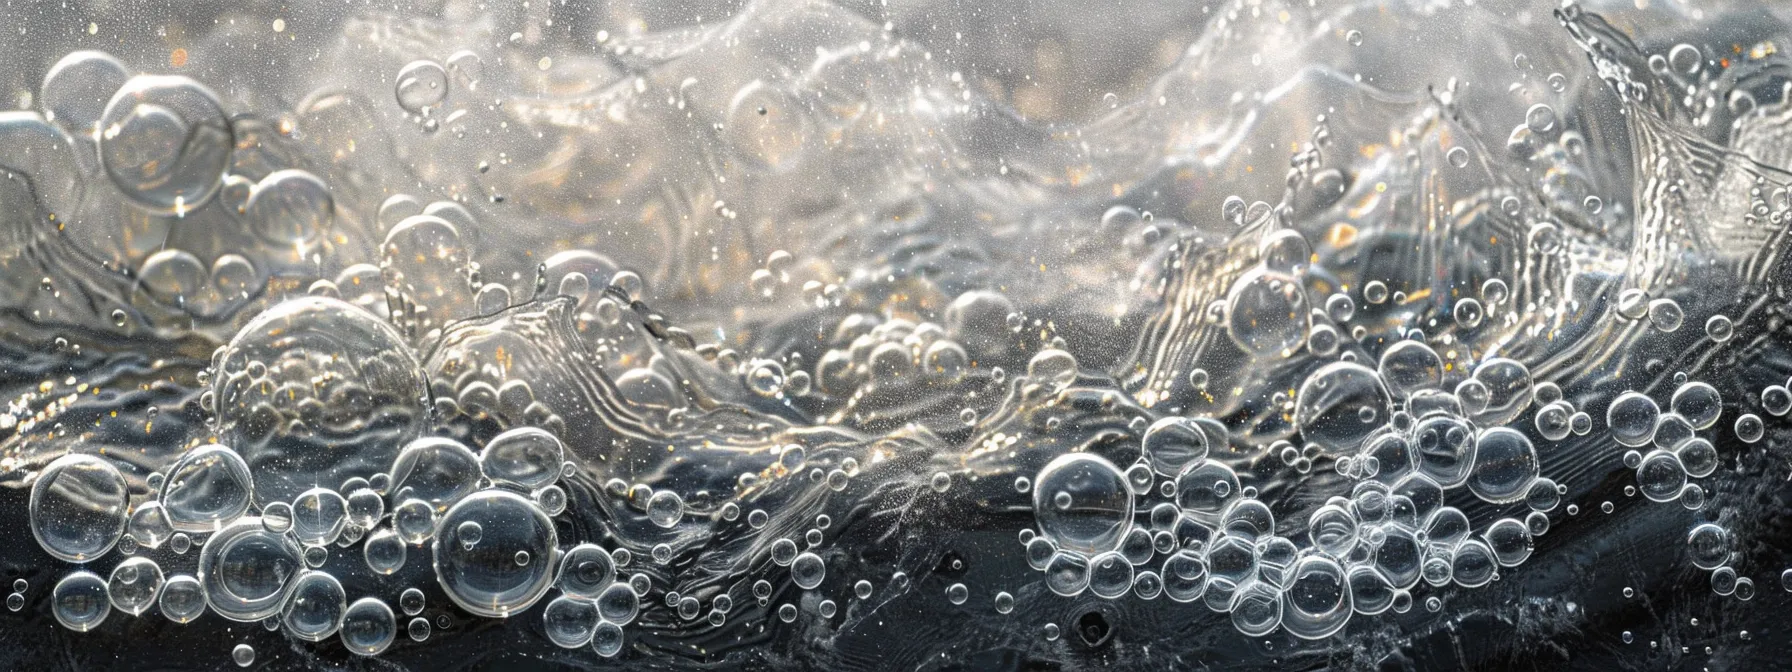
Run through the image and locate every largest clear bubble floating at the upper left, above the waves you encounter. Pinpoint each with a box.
[99,75,237,215]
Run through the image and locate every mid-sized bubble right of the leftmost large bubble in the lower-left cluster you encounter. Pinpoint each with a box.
[161,443,254,532]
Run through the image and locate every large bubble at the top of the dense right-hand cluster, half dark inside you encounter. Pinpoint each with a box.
[1294,362,1391,455]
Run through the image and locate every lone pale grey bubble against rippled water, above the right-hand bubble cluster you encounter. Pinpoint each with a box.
[1226,267,1308,357]
